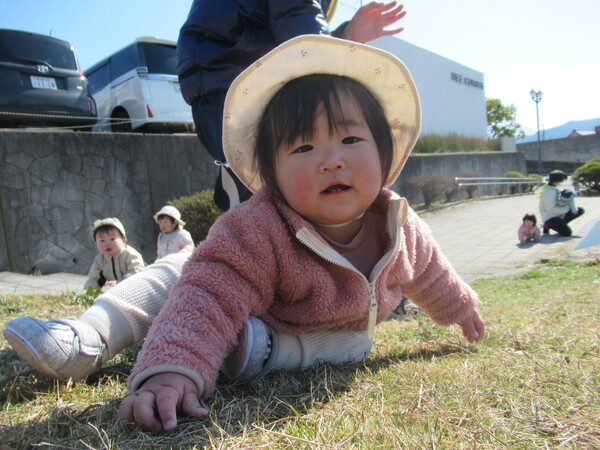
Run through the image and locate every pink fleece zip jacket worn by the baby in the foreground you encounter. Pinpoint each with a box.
[129,189,478,397]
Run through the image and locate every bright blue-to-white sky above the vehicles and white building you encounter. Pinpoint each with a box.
[0,0,600,132]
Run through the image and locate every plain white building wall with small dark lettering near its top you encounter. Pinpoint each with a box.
[369,36,487,139]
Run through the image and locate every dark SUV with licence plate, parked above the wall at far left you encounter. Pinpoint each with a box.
[0,29,96,129]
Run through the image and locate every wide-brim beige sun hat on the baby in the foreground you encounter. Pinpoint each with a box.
[223,35,421,192]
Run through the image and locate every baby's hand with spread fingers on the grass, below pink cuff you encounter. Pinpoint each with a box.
[119,372,208,431]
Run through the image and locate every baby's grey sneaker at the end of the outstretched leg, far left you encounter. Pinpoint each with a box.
[4,317,108,381]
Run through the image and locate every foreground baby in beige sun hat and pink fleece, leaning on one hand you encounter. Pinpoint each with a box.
[119,36,484,430]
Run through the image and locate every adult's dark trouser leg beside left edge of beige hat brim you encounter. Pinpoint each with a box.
[192,91,252,211]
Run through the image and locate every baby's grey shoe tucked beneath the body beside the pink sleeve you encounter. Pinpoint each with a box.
[221,316,279,381]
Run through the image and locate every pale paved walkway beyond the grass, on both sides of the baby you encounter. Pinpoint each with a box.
[0,195,600,295]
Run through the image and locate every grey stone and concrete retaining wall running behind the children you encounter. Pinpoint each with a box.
[0,130,525,274]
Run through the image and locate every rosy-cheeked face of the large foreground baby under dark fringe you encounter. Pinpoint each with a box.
[275,95,383,239]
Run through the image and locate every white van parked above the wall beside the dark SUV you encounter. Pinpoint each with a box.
[85,37,194,132]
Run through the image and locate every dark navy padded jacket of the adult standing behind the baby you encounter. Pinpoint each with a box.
[177,0,337,104]
